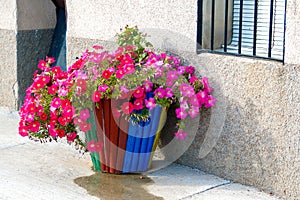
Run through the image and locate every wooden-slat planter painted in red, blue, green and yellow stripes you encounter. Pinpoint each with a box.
[87,99,167,174]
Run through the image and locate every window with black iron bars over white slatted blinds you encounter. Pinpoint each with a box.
[197,0,286,61]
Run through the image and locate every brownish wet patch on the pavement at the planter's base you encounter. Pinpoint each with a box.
[74,172,163,200]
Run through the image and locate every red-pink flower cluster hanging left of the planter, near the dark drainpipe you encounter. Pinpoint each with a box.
[19,57,83,149]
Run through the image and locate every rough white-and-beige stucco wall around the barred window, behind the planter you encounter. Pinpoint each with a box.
[67,0,300,199]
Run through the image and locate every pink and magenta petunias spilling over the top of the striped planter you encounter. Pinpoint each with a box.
[71,28,215,139]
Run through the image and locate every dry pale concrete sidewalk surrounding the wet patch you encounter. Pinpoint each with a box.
[0,108,277,200]
